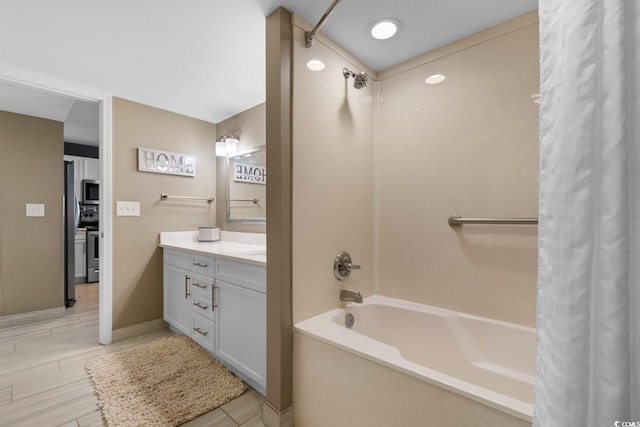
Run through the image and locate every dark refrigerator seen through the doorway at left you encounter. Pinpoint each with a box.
[63,161,80,307]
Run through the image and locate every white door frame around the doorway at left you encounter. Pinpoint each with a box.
[0,70,113,345]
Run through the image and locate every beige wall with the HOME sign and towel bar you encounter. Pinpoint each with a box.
[113,98,217,329]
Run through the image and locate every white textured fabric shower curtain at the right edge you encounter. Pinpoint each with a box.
[534,0,640,427]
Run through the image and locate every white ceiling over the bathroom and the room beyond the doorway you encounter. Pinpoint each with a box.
[0,0,537,144]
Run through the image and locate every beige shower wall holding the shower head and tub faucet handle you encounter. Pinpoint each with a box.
[292,16,375,323]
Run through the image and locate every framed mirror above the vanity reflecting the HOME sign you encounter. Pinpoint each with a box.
[227,145,267,224]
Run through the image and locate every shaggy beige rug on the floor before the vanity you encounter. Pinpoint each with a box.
[86,335,246,427]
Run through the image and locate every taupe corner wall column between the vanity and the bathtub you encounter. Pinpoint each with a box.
[263,8,293,427]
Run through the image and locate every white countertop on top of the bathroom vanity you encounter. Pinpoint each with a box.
[160,231,267,266]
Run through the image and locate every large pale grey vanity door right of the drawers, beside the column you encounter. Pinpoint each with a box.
[215,280,267,394]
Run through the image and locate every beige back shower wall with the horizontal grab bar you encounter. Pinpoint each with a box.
[376,12,539,326]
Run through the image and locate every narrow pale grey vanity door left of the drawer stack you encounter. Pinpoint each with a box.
[163,264,191,336]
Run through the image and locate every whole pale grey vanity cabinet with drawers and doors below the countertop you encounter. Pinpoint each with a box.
[163,248,267,394]
